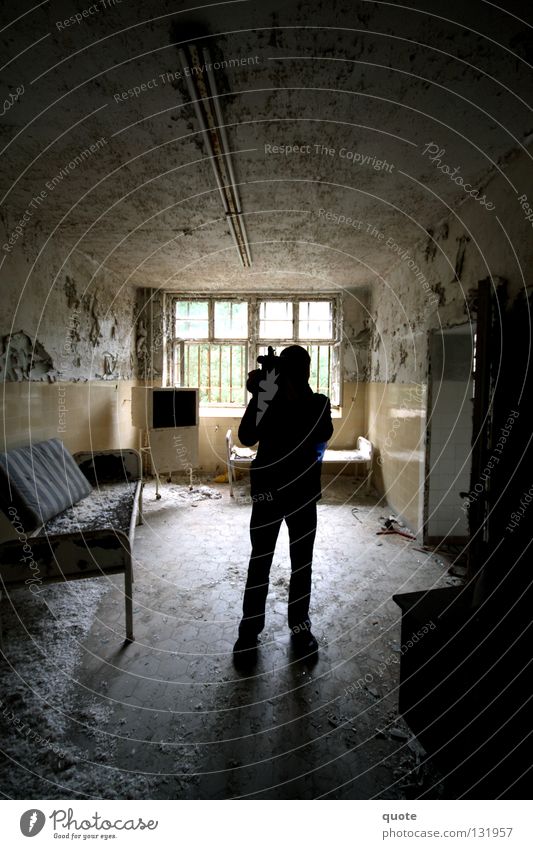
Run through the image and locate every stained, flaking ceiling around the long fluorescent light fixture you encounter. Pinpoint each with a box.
[1,0,533,292]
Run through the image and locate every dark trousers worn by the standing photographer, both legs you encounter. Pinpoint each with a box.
[239,501,316,636]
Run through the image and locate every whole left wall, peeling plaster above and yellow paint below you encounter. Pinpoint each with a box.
[0,222,138,450]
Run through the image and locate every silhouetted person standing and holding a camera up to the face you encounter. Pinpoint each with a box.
[233,345,333,665]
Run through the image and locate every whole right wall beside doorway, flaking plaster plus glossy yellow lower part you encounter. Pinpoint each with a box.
[367,146,533,529]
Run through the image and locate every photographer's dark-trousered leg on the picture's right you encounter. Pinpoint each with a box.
[285,502,316,634]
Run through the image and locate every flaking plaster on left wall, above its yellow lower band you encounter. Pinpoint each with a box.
[0,234,136,383]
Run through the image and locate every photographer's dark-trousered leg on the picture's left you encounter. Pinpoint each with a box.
[239,502,283,638]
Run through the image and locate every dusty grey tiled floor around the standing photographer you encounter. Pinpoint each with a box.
[1,478,453,799]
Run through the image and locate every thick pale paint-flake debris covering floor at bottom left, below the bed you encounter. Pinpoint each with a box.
[0,579,154,799]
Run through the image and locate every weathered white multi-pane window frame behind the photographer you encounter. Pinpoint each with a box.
[165,292,342,411]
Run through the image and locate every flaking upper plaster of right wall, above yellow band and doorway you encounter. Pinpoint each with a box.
[370,146,533,383]
